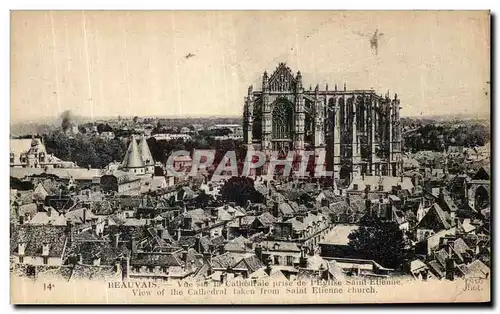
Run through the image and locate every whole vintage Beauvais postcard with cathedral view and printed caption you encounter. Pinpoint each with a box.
[10,11,492,304]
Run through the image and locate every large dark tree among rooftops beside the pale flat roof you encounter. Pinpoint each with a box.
[349,216,405,268]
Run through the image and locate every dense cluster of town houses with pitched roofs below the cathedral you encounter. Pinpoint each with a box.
[10,137,491,282]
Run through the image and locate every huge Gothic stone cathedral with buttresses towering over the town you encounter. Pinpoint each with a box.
[243,63,402,178]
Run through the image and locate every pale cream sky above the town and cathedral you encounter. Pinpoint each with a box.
[11,11,490,122]
